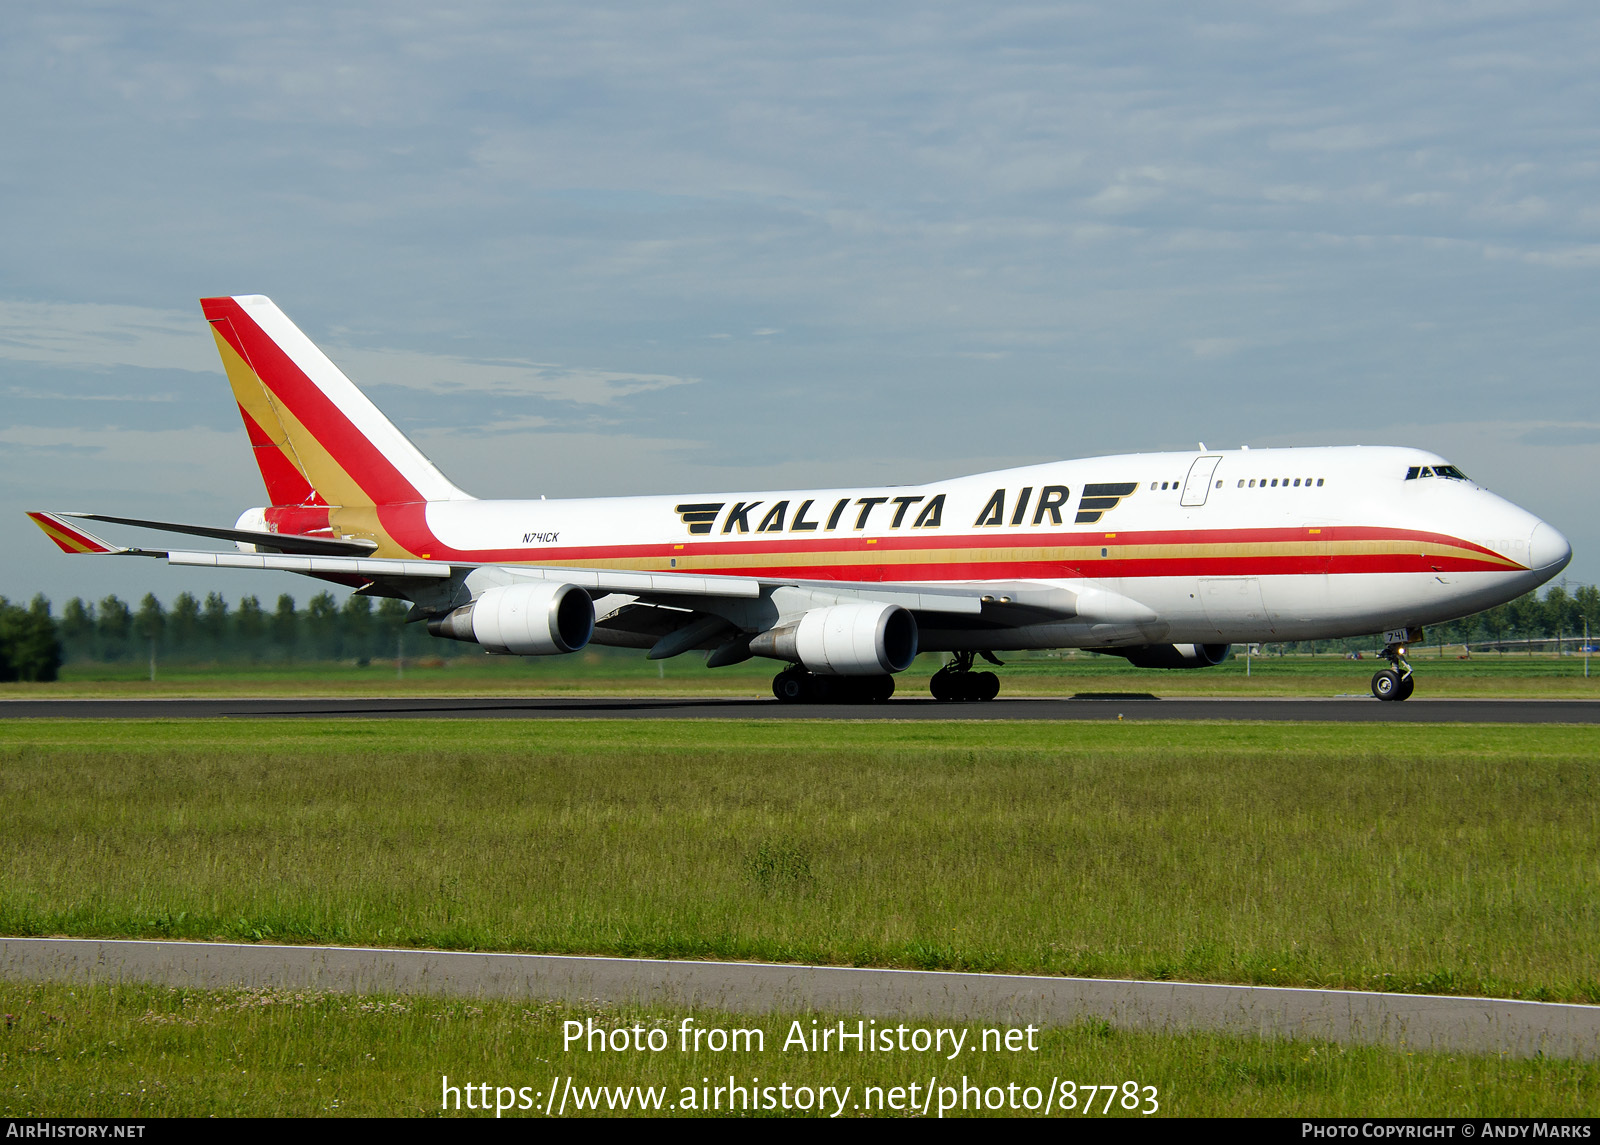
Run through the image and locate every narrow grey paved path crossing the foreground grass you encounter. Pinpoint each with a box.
[0,939,1600,1059]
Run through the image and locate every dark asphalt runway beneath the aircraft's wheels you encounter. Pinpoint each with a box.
[0,692,1600,724]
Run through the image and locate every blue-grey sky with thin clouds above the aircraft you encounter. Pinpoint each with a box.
[0,0,1600,608]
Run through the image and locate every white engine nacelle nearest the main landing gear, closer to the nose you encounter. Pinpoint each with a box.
[750,601,917,676]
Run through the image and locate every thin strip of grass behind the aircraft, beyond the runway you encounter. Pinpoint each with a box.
[12,646,1600,699]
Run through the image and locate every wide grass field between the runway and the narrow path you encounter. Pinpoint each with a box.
[0,721,1600,1003]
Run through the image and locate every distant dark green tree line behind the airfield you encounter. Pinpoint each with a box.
[9,585,1600,681]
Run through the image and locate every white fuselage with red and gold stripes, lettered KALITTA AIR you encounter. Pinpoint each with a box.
[347,446,1571,651]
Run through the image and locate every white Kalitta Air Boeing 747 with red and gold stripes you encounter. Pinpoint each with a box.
[30,294,1571,702]
